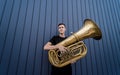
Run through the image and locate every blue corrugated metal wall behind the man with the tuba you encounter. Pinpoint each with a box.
[0,0,120,75]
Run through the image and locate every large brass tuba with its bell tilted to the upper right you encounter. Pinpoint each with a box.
[48,19,102,67]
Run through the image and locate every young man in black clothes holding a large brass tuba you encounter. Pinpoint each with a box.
[44,23,72,75]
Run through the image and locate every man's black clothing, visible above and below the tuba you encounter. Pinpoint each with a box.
[49,35,72,75]
